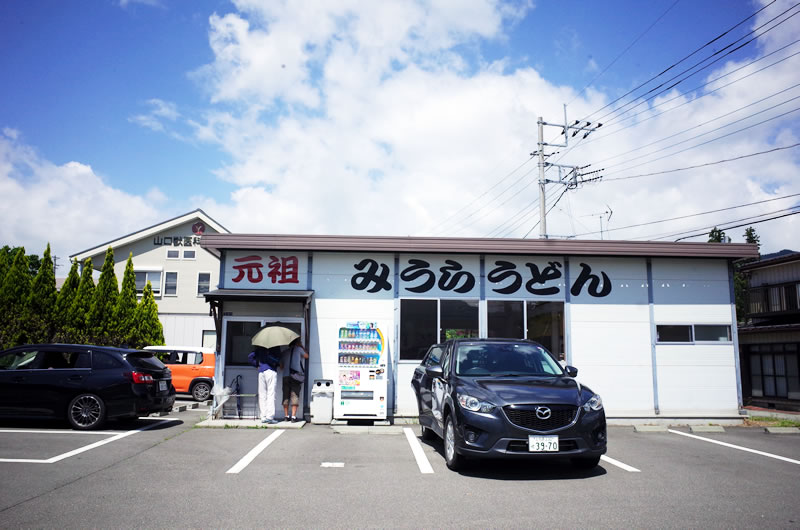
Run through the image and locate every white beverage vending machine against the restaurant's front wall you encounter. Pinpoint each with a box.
[333,321,388,420]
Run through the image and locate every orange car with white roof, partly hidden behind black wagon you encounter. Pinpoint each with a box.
[145,346,217,401]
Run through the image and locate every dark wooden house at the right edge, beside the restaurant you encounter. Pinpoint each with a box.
[739,252,800,410]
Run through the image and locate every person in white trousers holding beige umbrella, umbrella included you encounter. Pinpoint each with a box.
[248,326,299,425]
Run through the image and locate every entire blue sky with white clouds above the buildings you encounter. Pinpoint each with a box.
[0,0,800,264]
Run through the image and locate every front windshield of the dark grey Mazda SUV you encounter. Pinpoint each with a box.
[456,342,564,377]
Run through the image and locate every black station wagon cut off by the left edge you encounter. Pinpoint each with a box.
[0,344,175,430]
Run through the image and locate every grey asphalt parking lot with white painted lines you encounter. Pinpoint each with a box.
[0,402,800,528]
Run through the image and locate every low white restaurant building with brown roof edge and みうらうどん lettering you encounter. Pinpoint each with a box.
[201,233,758,419]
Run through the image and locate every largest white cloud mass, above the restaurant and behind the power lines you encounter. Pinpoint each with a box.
[170,0,800,250]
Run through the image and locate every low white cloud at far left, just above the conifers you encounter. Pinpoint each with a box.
[0,130,164,266]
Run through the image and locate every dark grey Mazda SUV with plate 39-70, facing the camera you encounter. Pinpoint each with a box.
[411,339,606,470]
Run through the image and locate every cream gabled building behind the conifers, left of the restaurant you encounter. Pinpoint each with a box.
[70,209,228,347]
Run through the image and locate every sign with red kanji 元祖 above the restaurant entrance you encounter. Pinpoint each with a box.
[223,250,308,290]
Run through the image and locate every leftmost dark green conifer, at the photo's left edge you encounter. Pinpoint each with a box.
[0,247,31,348]
